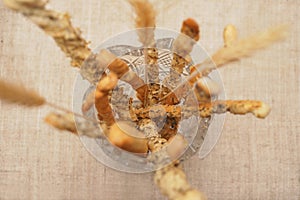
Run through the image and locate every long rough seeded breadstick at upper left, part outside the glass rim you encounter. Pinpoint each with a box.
[4,0,91,67]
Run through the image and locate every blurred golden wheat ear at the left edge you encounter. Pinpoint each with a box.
[0,80,46,106]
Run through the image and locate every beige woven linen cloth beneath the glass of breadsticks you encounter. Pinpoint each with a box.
[0,0,300,200]
